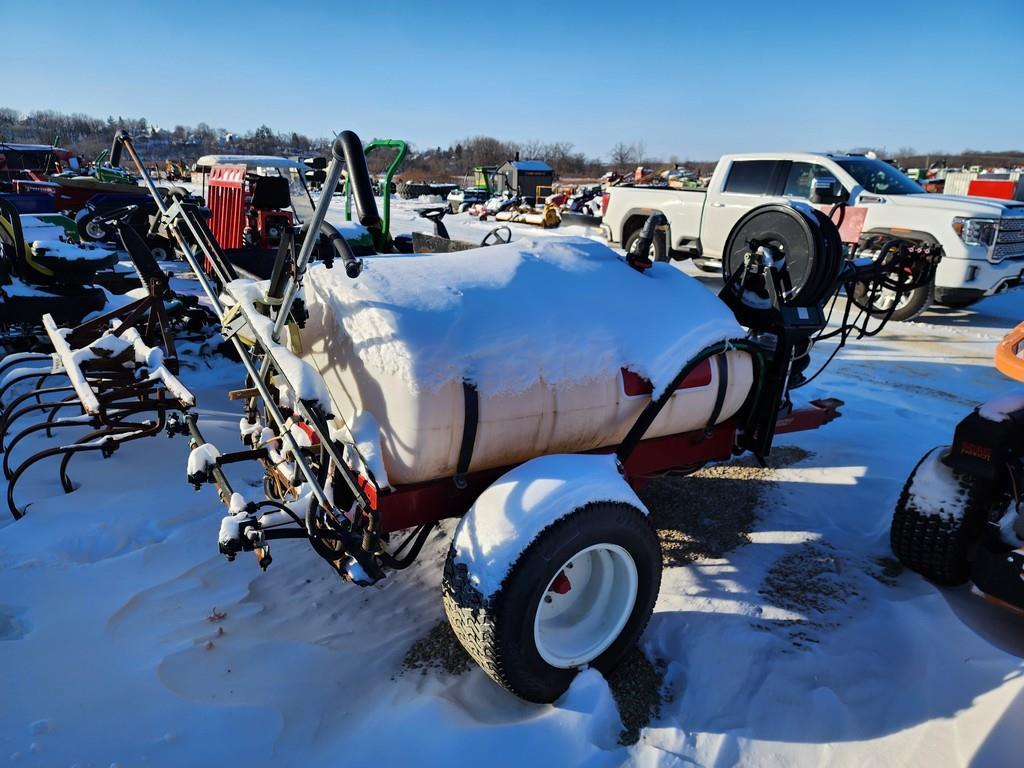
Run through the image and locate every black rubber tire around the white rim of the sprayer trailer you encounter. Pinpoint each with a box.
[441,502,662,703]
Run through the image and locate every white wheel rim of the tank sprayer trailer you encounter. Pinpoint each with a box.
[534,544,639,669]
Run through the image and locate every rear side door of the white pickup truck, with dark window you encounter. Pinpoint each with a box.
[700,160,782,259]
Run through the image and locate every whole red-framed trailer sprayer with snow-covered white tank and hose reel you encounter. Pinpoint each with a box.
[120,131,929,701]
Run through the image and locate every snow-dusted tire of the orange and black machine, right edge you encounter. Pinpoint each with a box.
[889,445,985,586]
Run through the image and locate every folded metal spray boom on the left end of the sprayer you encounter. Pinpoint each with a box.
[109,131,390,581]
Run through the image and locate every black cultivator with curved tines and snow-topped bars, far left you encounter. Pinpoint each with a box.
[0,280,196,519]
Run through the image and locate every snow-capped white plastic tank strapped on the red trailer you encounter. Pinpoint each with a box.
[302,238,752,483]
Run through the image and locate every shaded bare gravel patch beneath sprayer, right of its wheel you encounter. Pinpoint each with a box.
[640,445,811,567]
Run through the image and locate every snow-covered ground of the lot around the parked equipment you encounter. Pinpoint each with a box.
[0,202,1024,768]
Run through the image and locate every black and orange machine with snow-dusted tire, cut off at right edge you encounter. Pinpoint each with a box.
[890,323,1024,614]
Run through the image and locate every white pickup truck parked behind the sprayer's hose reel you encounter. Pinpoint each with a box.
[601,153,1024,319]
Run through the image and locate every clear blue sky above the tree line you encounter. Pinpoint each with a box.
[0,0,1024,159]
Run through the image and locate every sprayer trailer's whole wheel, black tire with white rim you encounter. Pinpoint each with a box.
[441,502,662,702]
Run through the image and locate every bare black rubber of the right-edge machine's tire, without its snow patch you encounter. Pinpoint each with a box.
[889,446,987,586]
